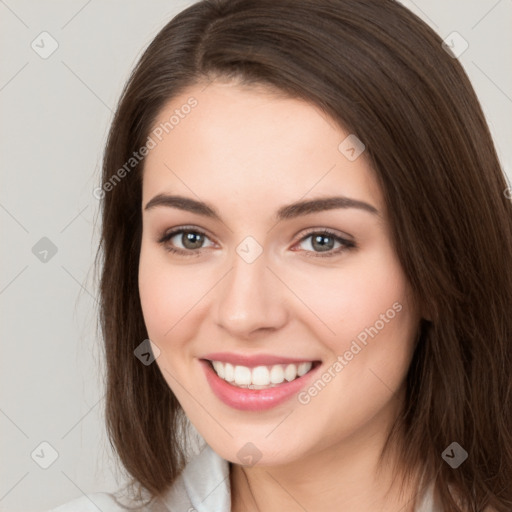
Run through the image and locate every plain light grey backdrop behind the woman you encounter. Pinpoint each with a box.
[0,0,512,512]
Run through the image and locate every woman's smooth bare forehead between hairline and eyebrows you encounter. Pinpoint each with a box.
[143,82,383,218]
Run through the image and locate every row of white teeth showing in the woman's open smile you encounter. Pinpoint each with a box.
[204,359,321,389]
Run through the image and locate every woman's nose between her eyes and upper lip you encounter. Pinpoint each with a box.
[215,251,289,339]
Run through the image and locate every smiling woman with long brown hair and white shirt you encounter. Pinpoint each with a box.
[50,0,512,512]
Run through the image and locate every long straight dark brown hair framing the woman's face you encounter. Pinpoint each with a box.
[96,0,512,512]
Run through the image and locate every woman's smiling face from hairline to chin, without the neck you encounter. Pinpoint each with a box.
[139,81,420,465]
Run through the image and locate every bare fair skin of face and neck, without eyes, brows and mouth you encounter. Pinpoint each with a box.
[139,80,421,512]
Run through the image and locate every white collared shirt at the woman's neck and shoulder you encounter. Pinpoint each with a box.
[48,444,440,512]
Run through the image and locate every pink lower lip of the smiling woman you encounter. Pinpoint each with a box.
[199,359,320,411]
